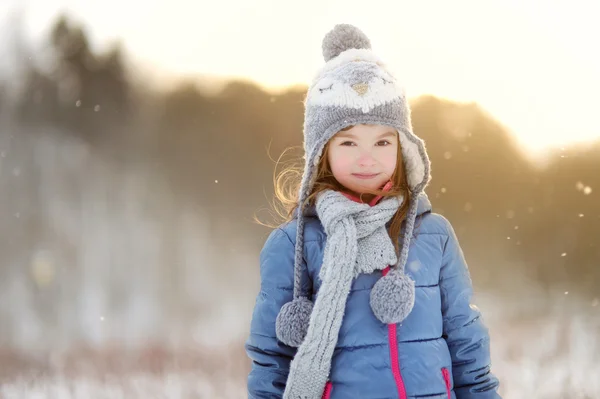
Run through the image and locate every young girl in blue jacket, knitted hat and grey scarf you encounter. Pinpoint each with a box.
[246,25,500,399]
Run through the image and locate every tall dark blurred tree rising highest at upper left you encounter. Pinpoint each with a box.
[19,15,131,139]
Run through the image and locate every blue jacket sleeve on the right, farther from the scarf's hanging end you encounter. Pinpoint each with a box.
[440,220,500,399]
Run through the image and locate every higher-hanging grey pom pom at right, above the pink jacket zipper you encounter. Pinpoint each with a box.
[370,269,415,324]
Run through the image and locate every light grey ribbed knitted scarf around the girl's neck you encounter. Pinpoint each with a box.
[283,191,402,399]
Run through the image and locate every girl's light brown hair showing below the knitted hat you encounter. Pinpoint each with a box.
[255,126,412,252]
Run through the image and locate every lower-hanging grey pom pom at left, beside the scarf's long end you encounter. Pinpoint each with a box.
[275,297,313,348]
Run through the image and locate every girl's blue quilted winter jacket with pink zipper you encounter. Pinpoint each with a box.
[246,194,500,399]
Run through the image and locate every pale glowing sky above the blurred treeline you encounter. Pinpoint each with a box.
[0,0,600,157]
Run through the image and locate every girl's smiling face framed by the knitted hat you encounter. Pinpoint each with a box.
[327,125,398,194]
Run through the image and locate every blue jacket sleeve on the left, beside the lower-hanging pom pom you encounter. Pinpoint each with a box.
[245,229,297,399]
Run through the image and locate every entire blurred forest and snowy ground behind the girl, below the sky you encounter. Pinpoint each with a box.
[0,7,600,399]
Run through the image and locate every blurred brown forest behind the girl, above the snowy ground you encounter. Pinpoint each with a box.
[0,10,600,398]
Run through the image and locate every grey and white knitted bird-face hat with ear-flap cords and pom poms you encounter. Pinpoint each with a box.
[276,24,430,347]
